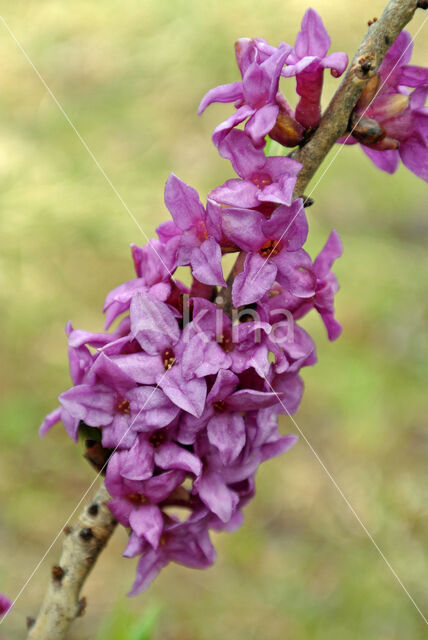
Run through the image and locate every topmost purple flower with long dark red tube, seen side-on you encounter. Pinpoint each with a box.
[282,9,348,129]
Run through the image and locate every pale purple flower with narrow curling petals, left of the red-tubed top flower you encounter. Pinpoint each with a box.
[199,40,291,147]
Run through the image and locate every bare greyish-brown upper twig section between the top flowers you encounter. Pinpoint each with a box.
[293,0,418,197]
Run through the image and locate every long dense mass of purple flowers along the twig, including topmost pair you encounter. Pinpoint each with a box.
[40,6,346,594]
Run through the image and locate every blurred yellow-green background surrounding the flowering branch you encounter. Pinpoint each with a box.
[0,0,428,640]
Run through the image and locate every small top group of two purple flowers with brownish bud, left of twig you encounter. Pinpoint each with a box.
[199,9,348,149]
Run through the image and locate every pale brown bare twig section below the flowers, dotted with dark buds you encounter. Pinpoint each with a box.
[27,484,117,640]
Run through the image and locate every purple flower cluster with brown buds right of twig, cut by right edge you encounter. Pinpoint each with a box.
[346,31,428,181]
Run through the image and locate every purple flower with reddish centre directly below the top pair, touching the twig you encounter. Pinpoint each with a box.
[208,129,302,209]
